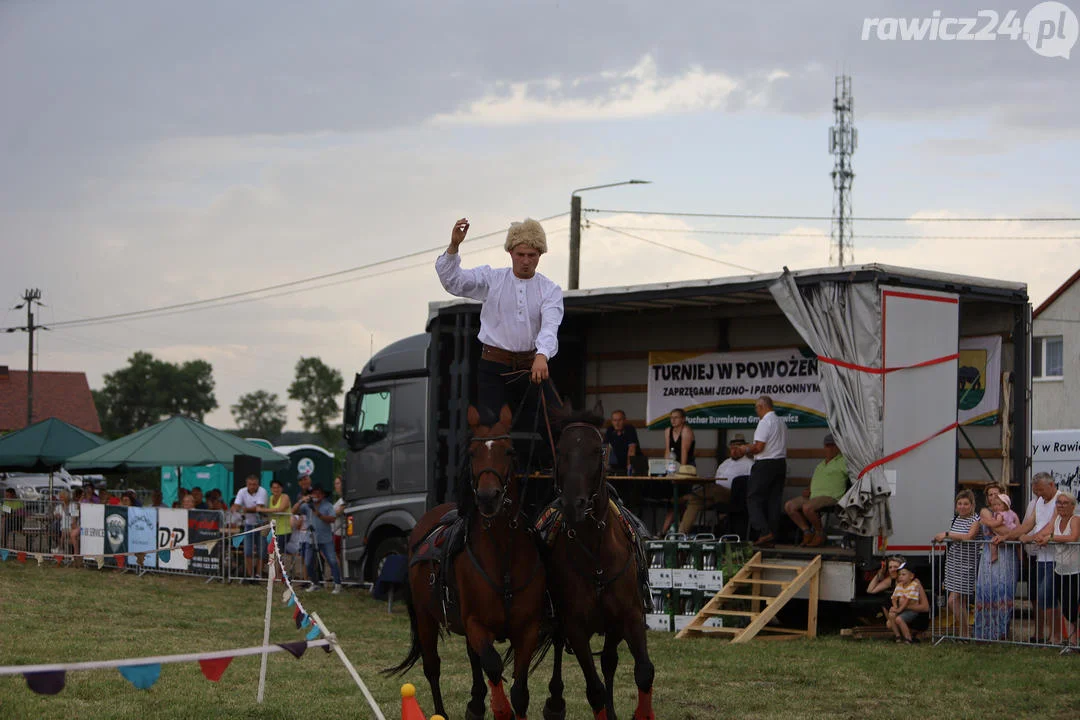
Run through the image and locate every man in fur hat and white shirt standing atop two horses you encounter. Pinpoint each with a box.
[435,218,563,431]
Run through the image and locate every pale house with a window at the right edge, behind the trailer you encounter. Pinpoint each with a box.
[1031,270,1080,430]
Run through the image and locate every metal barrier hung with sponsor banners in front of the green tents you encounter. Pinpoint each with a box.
[0,498,231,582]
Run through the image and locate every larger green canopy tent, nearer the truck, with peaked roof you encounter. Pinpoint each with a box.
[64,416,288,505]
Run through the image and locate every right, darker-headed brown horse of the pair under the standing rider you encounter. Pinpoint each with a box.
[543,422,656,720]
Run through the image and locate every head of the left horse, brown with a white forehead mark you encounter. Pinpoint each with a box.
[469,405,515,518]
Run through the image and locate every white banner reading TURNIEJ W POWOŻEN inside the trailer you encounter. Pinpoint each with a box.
[647,348,827,430]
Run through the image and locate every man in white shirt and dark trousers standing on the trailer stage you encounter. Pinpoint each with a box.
[744,395,787,547]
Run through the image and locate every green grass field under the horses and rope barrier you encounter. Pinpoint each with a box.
[0,559,1080,720]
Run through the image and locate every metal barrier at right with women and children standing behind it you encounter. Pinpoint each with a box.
[927,540,1080,650]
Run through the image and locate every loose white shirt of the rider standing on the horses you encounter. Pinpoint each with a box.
[435,253,563,359]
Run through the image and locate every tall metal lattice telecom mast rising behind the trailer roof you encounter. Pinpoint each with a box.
[828,74,859,268]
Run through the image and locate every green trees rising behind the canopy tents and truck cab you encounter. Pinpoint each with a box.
[93,351,345,447]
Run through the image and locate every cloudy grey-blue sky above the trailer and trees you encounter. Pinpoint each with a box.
[0,0,1080,429]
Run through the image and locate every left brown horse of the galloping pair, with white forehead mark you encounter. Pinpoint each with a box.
[387,406,545,720]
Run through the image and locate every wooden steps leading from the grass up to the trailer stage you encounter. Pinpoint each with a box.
[675,553,821,642]
